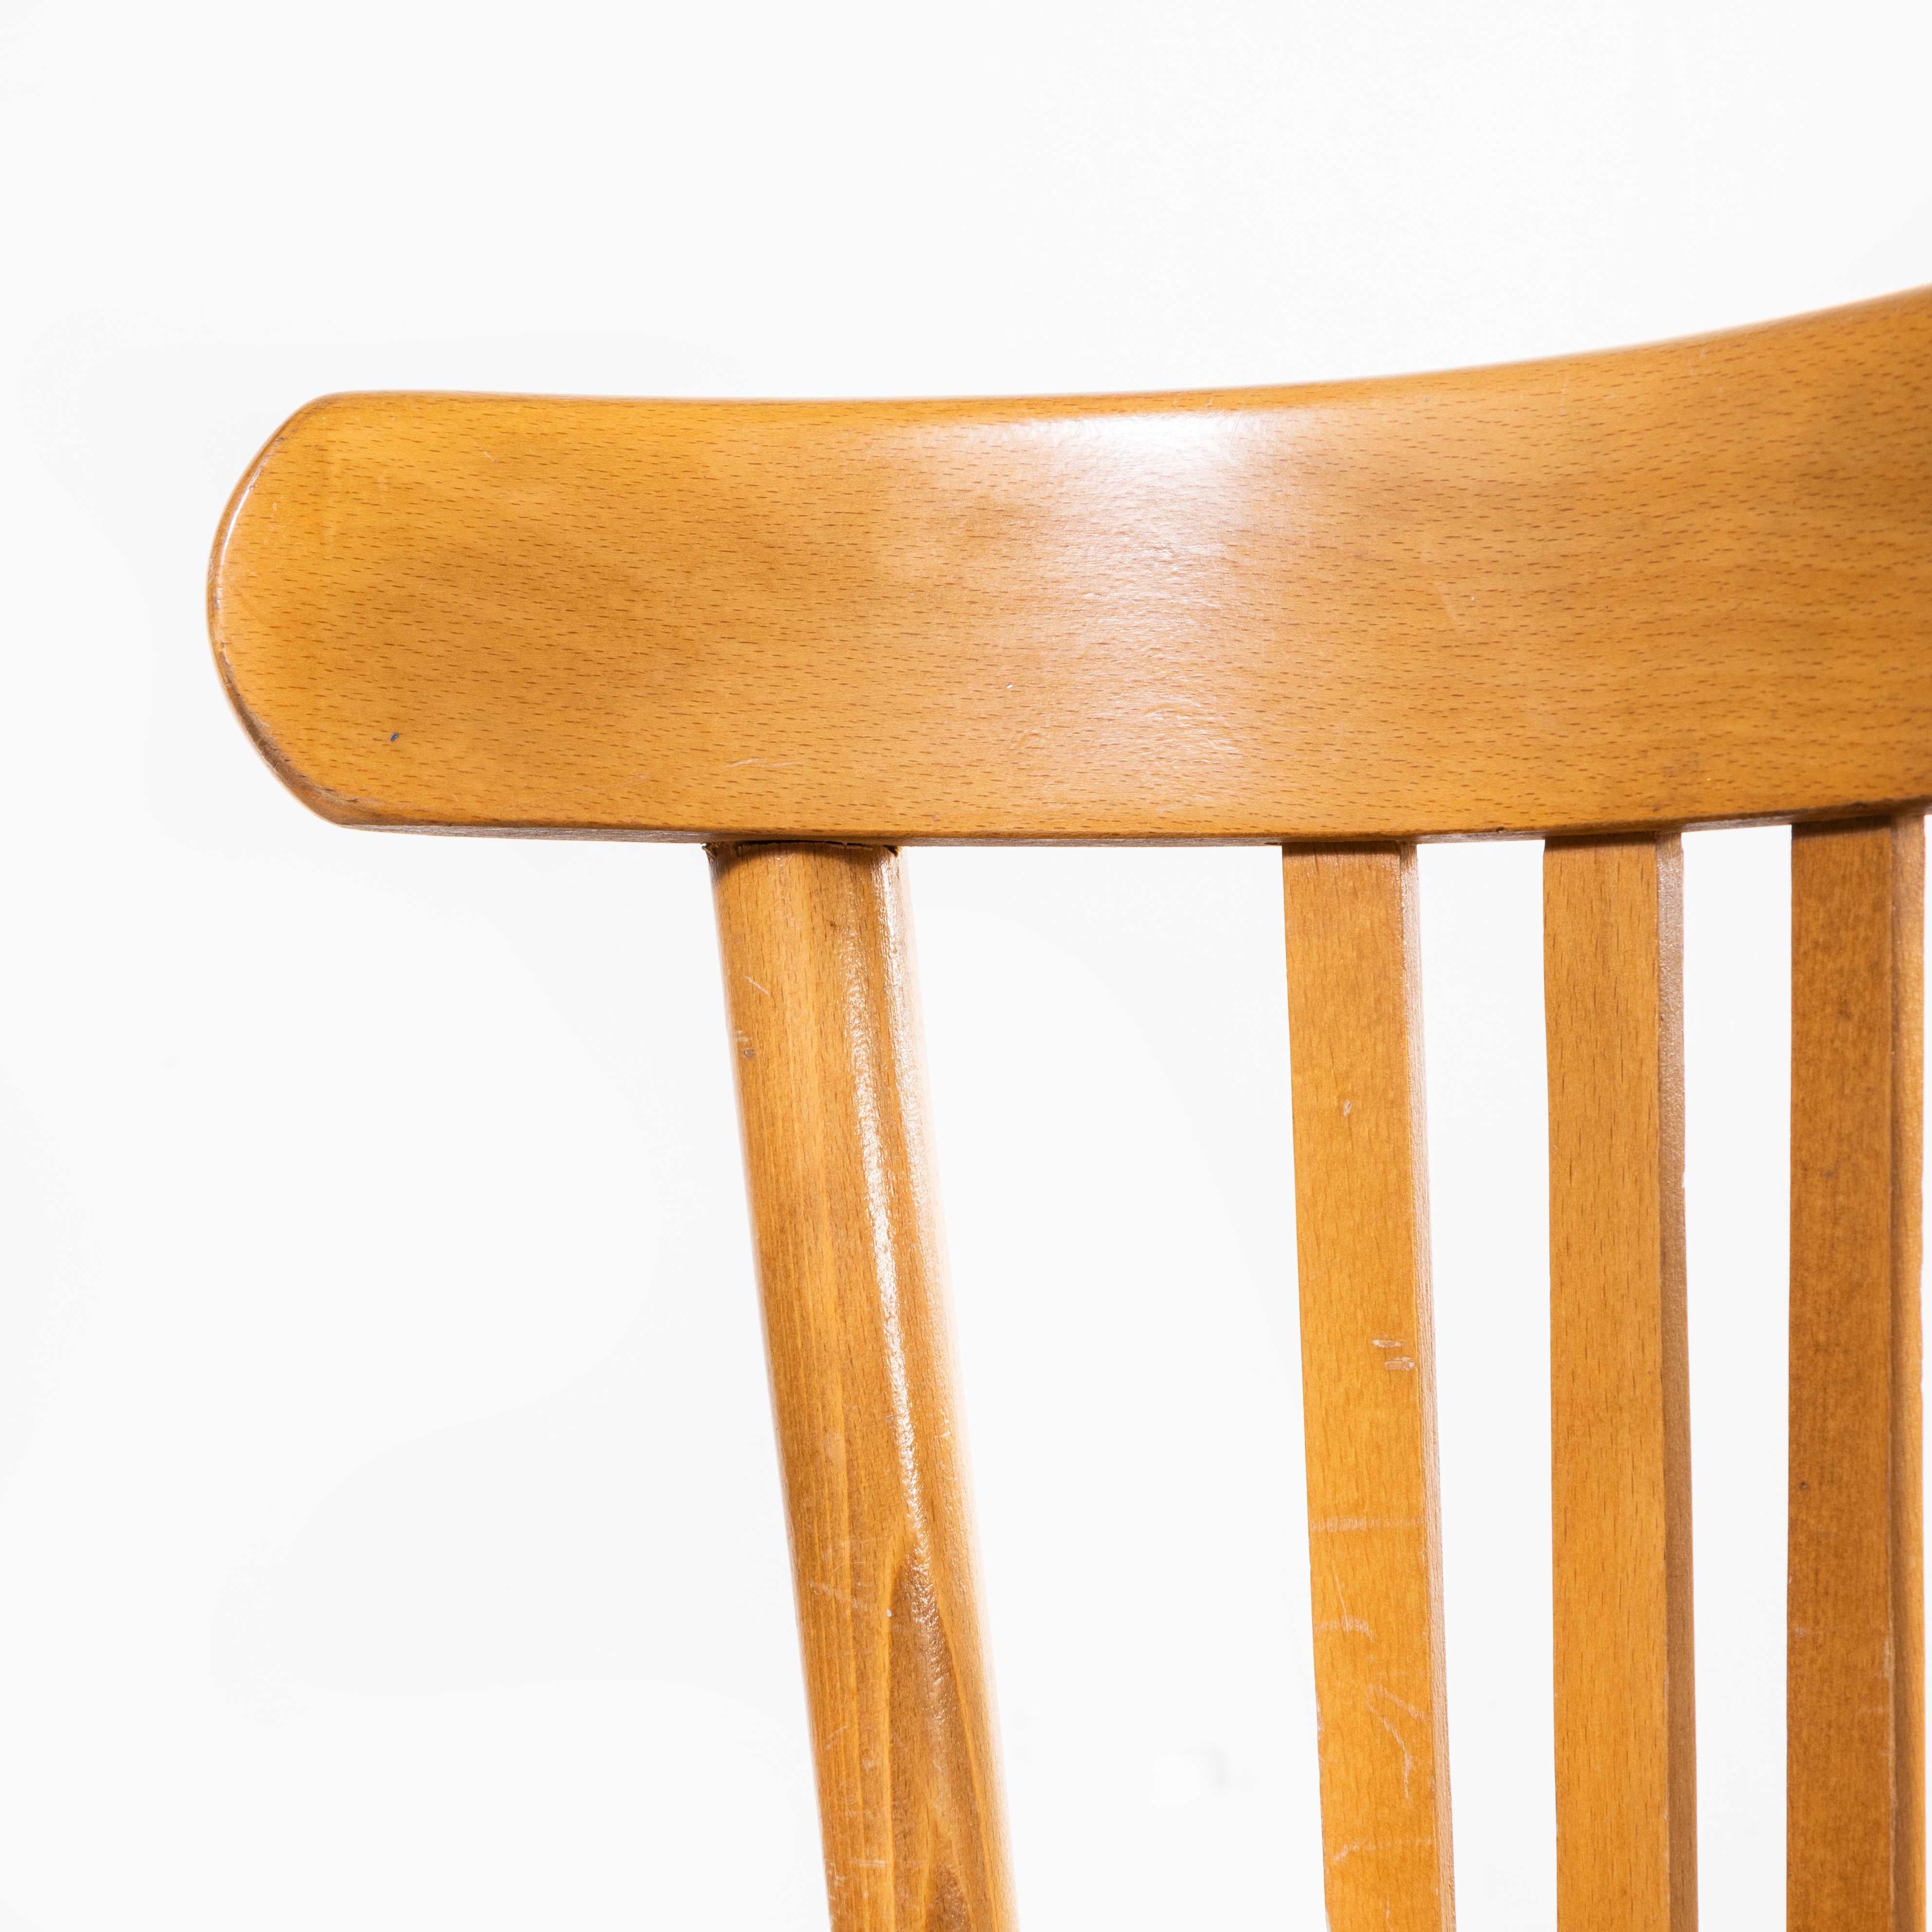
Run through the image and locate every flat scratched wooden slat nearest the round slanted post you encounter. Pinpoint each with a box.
[1283,846,1455,1932]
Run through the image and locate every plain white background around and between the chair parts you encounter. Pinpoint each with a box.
[0,0,1932,1932]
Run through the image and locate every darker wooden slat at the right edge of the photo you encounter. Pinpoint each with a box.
[1785,817,1924,1932]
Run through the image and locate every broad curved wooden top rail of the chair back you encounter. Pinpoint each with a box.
[208,292,1932,843]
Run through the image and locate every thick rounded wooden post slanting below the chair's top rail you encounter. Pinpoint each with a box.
[713,846,1014,1932]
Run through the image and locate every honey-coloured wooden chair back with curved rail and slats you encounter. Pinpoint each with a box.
[208,290,1932,1932]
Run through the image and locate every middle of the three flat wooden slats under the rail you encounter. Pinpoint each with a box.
[1544,839,1696,1932]
